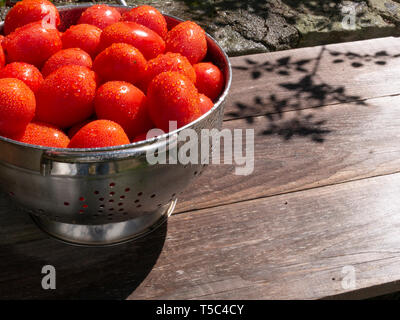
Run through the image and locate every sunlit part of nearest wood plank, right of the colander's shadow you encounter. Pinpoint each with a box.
[129,174,400,299]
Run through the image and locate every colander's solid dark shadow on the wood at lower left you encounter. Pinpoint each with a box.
[0,194,167,300]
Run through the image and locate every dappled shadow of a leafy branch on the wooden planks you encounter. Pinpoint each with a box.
[227,46,400,143]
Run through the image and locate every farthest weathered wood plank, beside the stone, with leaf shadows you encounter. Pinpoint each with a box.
[225,37,400,119]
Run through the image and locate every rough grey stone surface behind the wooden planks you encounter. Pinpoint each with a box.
[2,0,400,56]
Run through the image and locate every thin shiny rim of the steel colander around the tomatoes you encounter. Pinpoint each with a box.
[0,3,232,156]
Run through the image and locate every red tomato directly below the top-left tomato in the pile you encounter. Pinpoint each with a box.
[3,22,62,67]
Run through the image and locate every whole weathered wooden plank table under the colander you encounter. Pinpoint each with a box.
[0,38,400,299]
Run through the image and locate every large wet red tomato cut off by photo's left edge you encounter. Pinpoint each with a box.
[0,78,36,136]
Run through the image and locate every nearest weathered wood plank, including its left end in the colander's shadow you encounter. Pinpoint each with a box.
[0,174,400,299]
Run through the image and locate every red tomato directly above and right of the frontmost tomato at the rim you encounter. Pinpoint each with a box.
[94,81,153,138]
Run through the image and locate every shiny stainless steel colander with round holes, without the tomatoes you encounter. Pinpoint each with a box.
[0,4,232,245]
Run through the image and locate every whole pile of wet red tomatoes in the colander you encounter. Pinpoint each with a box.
[0,0,224,148]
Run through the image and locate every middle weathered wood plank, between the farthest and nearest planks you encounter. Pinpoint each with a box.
[176,96,400,212]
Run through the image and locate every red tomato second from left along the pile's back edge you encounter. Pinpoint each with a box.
[78,4,121,29]
